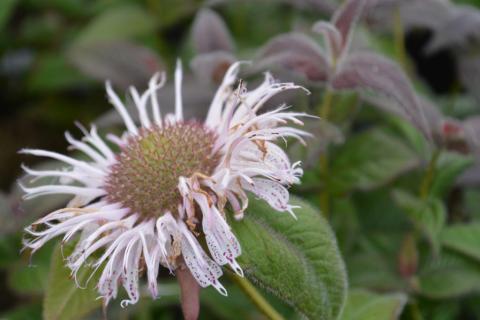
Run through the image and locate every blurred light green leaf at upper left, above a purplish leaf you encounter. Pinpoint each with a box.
[73,5,156,46]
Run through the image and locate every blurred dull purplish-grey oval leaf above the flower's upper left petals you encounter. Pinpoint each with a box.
[68,41,164,89]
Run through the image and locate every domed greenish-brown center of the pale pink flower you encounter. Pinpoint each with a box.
[105,122,219,218]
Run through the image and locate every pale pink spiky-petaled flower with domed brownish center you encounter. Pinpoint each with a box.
[21,62,308,307]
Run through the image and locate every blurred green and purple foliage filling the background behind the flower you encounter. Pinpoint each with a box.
[0,0,480,320]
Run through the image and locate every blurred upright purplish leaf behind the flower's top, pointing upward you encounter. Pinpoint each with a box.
[192,9,234,53]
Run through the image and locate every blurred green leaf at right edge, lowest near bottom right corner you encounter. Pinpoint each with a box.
[418,251,480,299]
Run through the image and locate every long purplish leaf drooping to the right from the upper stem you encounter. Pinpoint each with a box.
[331,52,430,139]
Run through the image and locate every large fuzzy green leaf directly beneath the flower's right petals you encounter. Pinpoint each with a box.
[232,197,347,320]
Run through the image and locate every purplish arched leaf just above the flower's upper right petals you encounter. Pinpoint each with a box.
[256,32,329,81]
